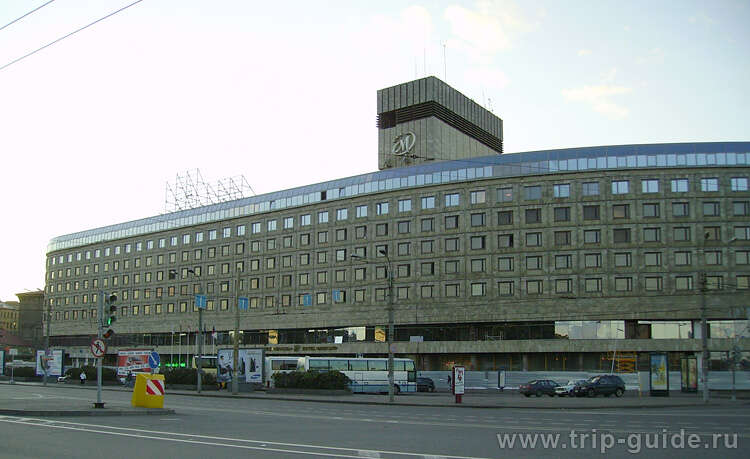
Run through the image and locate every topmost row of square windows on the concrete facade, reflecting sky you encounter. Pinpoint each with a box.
[49,173,748,265]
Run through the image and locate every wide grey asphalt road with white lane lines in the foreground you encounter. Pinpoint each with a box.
[0,385,750,458]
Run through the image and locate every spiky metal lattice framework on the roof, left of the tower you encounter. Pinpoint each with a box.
[164,169,255,213]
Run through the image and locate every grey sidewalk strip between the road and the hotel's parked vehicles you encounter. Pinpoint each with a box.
[0,383,750,416]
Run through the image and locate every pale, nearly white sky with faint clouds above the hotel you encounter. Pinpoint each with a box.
[0,0,750,301]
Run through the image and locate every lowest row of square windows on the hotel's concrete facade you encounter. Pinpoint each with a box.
[55,274,750,320]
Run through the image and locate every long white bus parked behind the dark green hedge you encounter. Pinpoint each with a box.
[264,356,417,394]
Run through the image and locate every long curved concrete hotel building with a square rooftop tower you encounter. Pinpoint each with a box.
[45,77,750,371]
